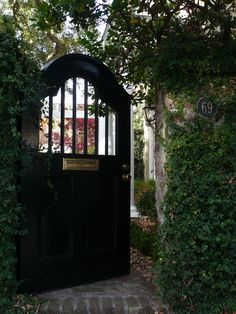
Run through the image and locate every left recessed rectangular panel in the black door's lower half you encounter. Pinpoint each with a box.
[39,176,74,259]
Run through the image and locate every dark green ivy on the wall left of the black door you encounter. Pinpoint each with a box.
[0,18,39,314]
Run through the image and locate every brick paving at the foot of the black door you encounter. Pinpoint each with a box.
[38,272,164,314]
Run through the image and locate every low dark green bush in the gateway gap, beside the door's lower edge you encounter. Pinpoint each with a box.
[130,220,157,260]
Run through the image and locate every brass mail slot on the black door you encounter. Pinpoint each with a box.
[63,158,99,171]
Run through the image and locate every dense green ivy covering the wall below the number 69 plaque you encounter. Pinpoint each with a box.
[156,79,236,314]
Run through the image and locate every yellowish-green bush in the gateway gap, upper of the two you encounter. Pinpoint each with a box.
[134,180,157,221]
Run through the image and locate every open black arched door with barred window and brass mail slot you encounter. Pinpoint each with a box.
[19,54,130,292]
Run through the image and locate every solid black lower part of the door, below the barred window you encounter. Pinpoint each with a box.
[21,154,129,291]
